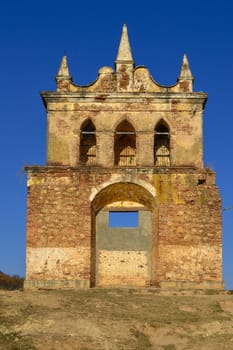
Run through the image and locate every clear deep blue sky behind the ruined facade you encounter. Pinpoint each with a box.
[0,0,233,289]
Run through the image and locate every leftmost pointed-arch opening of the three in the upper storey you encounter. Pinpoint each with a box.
[80,119,96,165]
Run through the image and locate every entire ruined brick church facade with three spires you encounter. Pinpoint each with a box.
[25,25,223,289]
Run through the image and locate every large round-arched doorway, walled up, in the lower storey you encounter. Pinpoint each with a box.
[91,182,156,287]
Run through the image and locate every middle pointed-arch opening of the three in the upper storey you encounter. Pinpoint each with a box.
[114,120,136,166]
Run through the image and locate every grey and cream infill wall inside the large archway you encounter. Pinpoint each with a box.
[96,206,152,286]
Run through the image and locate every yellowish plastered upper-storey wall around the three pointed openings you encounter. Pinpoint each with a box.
[43,93,203,167]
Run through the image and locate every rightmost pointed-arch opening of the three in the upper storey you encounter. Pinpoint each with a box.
[154,121,171,166]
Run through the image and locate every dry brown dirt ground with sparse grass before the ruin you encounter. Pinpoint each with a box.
[0,289,233,350]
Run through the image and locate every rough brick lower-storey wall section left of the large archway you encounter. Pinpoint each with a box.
[26,172,91,280]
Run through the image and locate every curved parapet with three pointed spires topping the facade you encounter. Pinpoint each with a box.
[56,25,194,93]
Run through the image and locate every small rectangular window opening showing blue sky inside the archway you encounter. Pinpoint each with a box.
[108,211,138,228]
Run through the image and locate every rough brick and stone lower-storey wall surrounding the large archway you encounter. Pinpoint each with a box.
[26,167,222,287]
